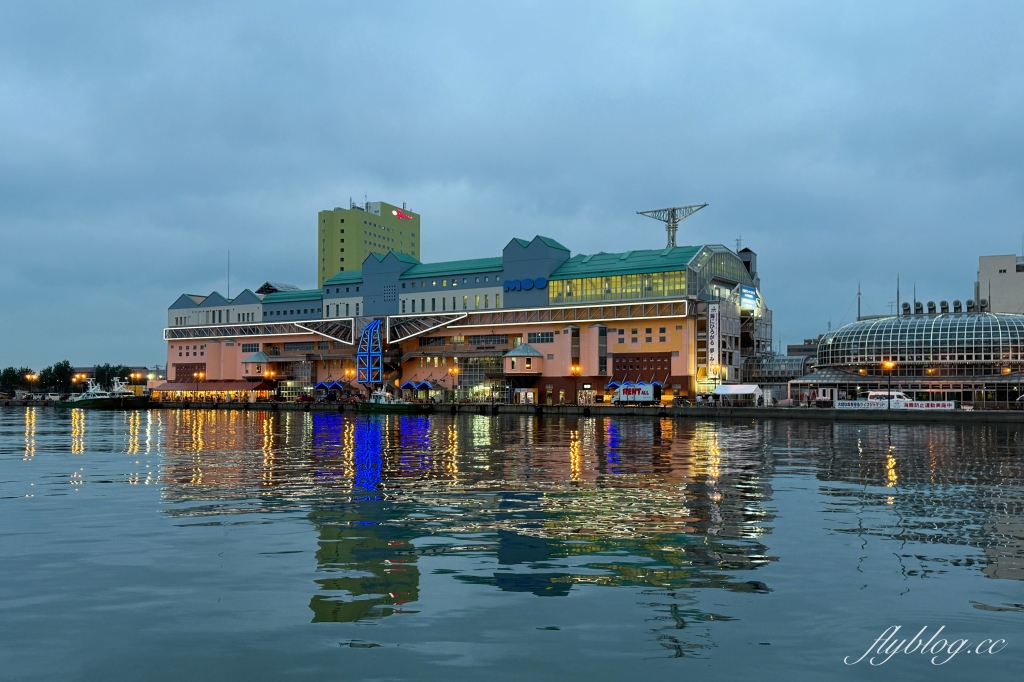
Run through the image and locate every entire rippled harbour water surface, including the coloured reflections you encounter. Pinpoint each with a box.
[0,409,1024,680]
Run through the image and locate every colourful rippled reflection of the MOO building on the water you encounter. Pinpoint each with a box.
[155,411,771,654]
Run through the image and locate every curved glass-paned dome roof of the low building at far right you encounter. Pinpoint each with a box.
[817,312,1024,370]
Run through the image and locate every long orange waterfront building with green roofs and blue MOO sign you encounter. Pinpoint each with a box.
[157,208,771,404]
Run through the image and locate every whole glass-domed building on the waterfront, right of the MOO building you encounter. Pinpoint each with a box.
[790,312,1024,402]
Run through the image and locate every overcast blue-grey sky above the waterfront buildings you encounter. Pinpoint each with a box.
[0,0,1024,368]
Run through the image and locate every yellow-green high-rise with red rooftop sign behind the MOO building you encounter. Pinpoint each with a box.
[316,197,420,287]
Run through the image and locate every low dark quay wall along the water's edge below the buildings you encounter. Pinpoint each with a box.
[6,400,1024,424]
